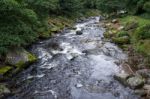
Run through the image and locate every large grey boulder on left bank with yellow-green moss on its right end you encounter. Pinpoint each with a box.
[6,48,37,68]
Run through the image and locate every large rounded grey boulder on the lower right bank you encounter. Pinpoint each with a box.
[127,76,144,89]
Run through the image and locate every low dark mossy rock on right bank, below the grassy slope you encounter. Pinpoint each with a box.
[112,36,130,44]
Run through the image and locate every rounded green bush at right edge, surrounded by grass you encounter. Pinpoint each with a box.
[136,24,150,40]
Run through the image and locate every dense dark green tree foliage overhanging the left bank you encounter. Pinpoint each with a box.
[0,0,55,54]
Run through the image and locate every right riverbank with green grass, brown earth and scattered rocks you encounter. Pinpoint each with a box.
[103,16,150,99]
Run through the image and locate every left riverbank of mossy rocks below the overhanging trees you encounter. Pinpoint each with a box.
[0,10,99,97]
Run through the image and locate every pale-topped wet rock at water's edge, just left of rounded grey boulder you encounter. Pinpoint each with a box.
[114,73,130,86]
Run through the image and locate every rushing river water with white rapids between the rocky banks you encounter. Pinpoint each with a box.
[8,17,139,99]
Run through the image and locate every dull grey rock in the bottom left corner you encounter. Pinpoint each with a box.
[0,84,11,98]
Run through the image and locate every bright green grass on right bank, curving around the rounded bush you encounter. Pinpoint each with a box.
[119,16,150,56]
